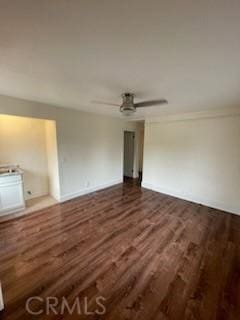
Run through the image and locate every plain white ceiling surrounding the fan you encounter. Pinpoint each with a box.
[0,0,240,118]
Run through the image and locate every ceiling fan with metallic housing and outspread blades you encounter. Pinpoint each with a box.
[92,92,168,116]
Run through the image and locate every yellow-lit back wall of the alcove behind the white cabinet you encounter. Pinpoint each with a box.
[0,115,48,199]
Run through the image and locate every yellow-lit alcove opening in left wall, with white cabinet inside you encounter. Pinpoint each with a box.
[0,114,60,222]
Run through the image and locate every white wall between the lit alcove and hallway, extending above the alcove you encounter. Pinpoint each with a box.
[0,96,132,200]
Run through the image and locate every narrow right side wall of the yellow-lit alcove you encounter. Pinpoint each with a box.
[45,120,60,200]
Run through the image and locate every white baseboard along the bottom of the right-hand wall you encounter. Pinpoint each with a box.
[142,181,240,215]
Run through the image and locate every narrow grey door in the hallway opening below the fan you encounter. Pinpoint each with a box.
[123,131,135,178]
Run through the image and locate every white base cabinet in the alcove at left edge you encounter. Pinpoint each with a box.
[0,174,25,216]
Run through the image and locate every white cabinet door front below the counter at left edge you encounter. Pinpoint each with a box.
[0,183,24,211]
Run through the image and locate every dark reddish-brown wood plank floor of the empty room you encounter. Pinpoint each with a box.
[0,183,240,320]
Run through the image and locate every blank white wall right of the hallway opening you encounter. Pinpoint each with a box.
[143,115,240,214]
